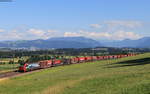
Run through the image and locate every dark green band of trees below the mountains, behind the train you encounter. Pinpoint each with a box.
[0,47,150,60]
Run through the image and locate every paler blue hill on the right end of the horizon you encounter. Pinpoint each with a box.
[102,37,150,48]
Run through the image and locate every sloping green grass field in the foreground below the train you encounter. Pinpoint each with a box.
[0,53,150,94]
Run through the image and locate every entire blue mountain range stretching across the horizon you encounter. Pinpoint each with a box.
[0,37,150,49]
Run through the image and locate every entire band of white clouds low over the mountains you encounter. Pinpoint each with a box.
[0,20,143,40]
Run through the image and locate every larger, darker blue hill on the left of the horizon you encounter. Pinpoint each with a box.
[0,37,100,49]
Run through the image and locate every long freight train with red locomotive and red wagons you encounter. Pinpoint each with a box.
[19,54,136,72]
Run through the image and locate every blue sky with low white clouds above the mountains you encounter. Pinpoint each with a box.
[0,0,150,40]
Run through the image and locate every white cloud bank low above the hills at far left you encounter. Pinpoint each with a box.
[0,28,60,40]
